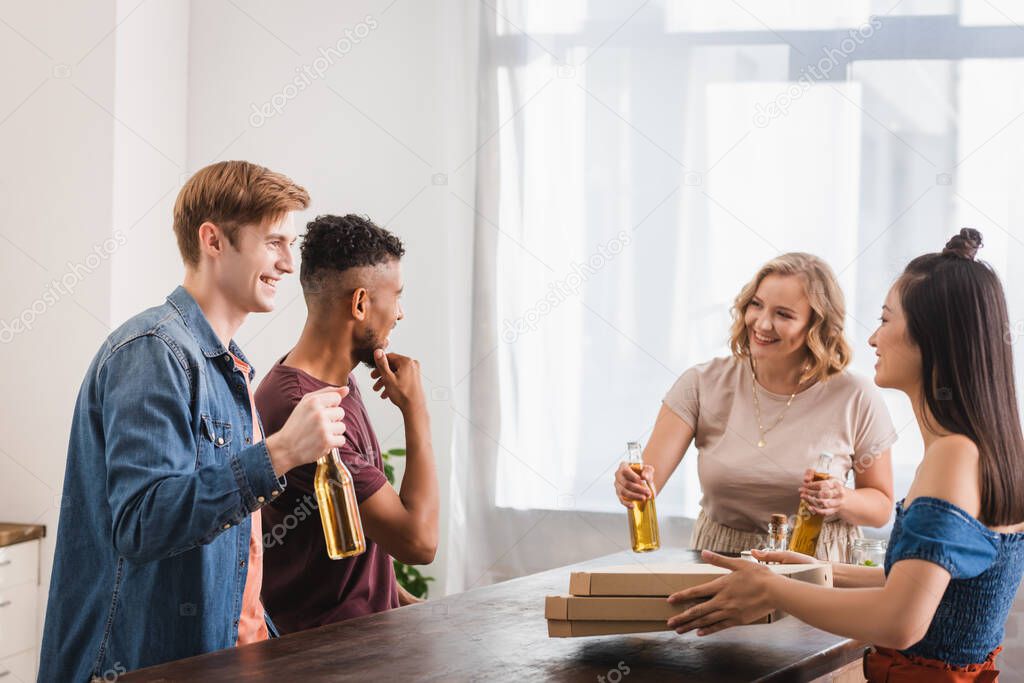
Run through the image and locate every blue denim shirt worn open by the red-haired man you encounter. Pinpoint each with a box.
[39,287,285,682]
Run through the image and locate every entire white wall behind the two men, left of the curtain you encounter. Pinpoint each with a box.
[0,0,476,647]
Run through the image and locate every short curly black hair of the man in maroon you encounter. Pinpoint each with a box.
[299,213,406,293]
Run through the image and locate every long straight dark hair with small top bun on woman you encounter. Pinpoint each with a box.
[898,227,1024,526]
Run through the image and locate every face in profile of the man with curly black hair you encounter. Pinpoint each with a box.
[353,259,404,368]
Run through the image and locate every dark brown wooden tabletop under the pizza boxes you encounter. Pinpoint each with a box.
[120,549,864,683]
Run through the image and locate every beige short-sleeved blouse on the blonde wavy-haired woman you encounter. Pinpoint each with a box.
[664,356,896,531]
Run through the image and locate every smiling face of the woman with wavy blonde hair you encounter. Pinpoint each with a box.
[743,273,812,362]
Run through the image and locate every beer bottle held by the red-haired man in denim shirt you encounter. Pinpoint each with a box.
[313,449,367,560]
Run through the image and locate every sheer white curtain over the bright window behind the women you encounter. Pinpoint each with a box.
[449,0,1024,590]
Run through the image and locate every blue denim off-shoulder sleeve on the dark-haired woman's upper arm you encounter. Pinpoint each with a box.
[891,497,998,579]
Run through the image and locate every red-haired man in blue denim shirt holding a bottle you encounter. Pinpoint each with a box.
[39,162,347,682]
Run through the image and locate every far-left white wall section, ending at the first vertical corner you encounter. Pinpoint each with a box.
[0,1,118,655]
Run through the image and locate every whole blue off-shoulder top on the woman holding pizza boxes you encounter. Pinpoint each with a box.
[885,497,1024,667]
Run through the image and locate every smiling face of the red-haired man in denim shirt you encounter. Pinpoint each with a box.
[215,212,296,313]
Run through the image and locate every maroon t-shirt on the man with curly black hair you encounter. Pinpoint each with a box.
[256,356,398,634]
